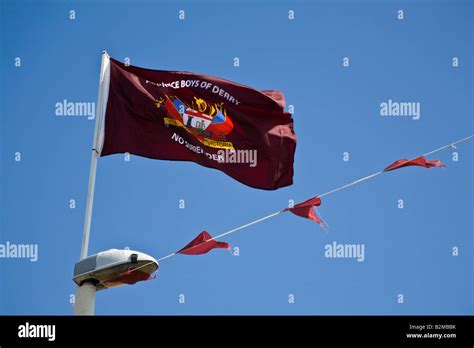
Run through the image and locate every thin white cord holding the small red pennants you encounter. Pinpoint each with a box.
[157,134,474,262]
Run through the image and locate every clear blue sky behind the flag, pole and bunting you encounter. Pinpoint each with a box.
[0,0,474,314]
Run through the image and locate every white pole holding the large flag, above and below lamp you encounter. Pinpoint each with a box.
[74,51,110,315]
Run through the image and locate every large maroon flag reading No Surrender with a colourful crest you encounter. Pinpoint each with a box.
[97,58,296,190]
